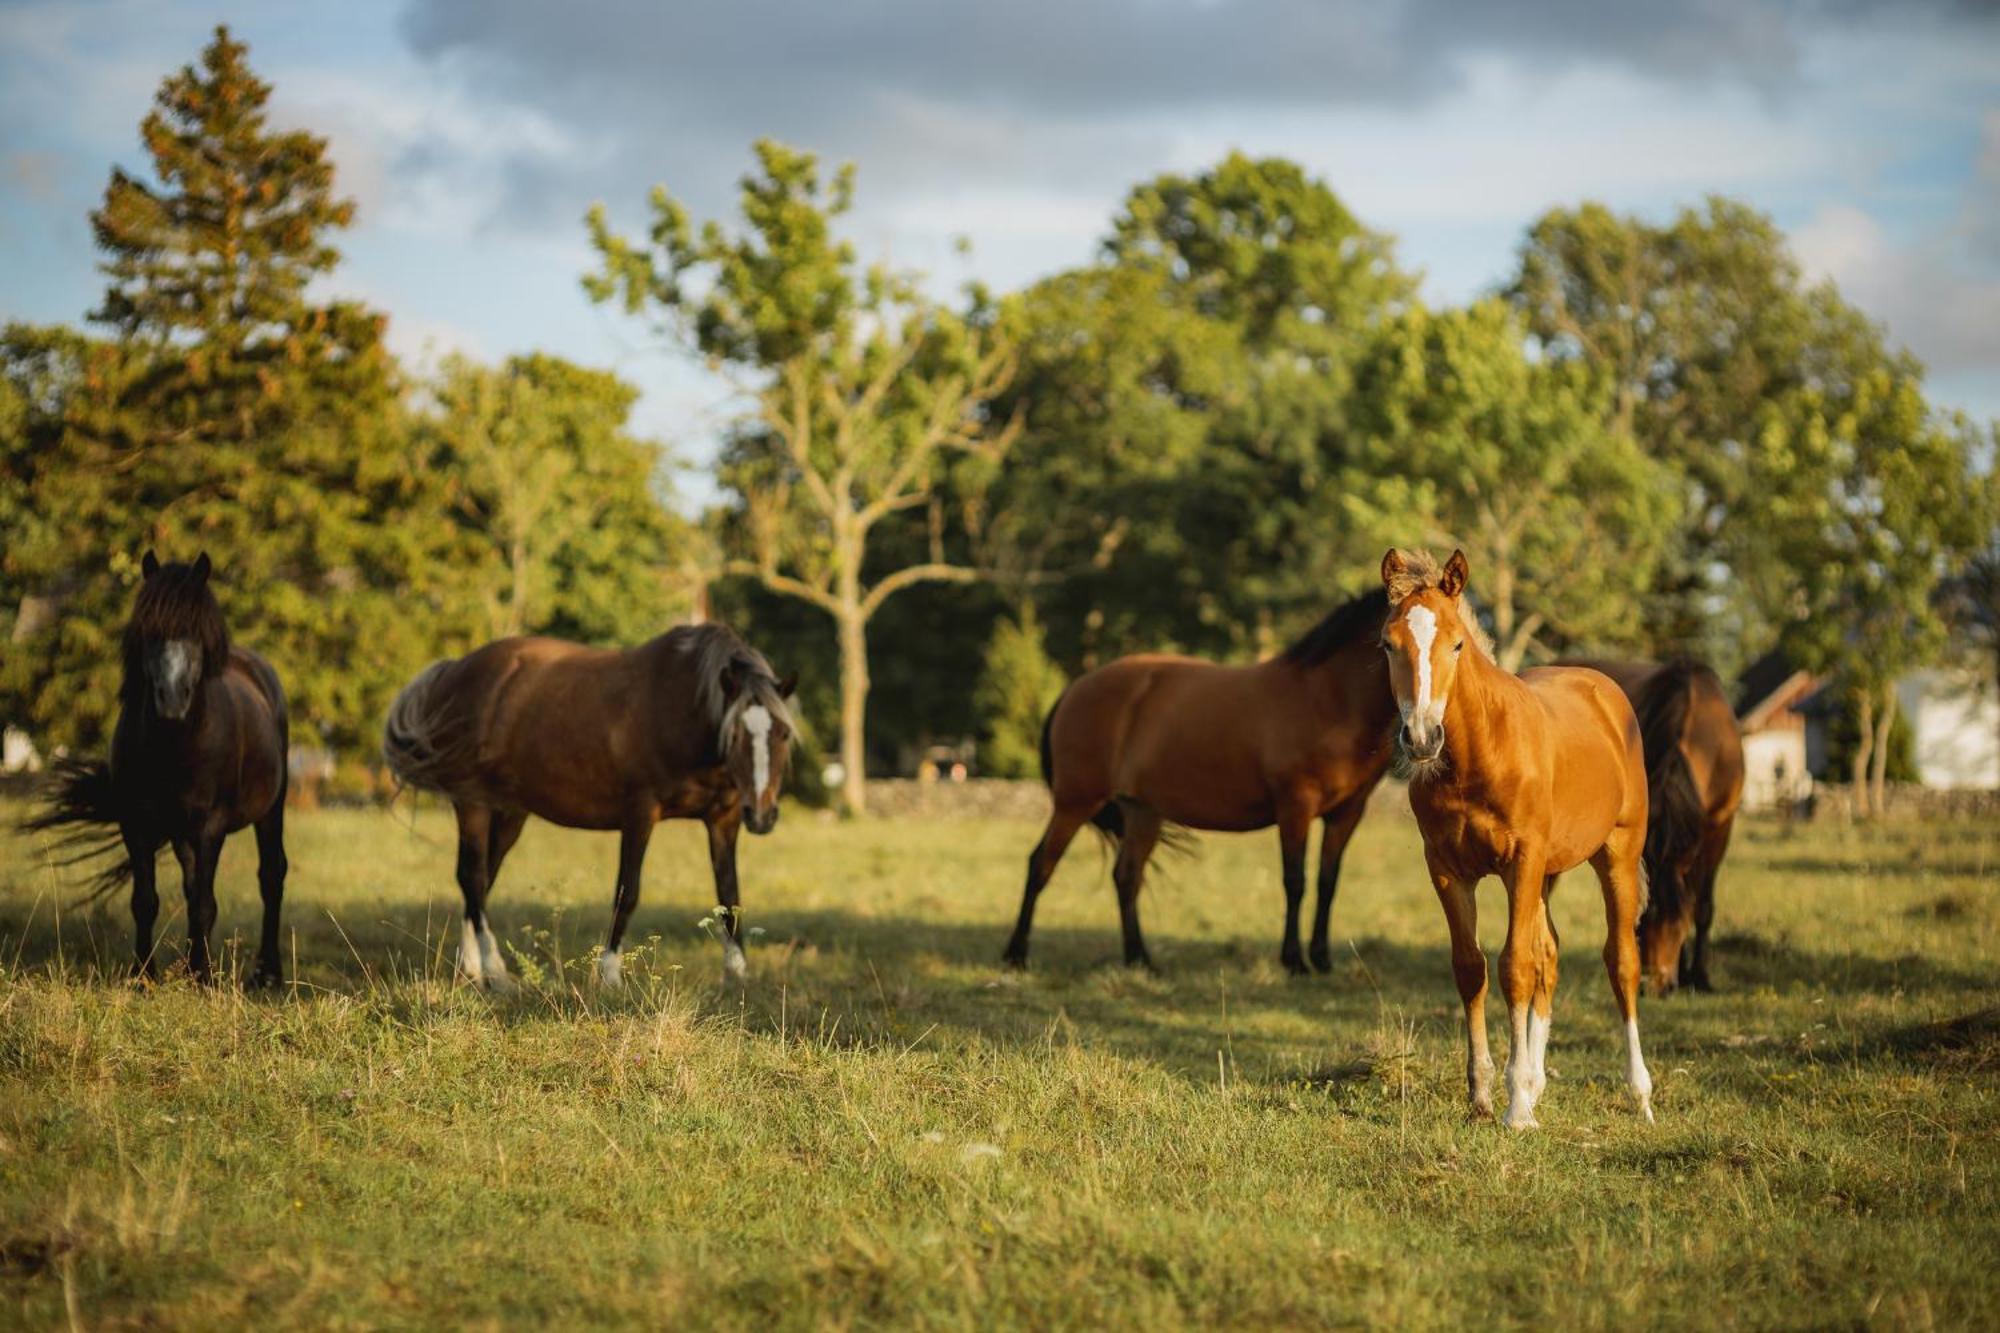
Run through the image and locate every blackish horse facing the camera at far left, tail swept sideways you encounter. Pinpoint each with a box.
[26,550,290,987]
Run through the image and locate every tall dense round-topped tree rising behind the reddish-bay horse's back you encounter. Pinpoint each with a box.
[990,154,1414,662]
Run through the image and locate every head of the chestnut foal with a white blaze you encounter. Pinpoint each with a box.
[1382,548,1476,777]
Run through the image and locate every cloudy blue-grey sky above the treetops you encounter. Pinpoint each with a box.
[0,0,2000,488]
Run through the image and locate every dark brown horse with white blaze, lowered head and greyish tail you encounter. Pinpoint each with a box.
[382,624,796,989]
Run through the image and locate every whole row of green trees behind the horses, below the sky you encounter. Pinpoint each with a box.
[0,30,2000,809]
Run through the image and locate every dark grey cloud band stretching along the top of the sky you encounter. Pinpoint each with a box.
[402,0,1994,244]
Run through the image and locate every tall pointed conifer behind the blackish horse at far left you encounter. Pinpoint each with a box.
[8,28,452,747]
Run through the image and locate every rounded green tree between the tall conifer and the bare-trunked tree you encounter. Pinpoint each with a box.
[422,354,690,642]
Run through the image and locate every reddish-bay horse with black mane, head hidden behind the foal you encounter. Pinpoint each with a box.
[1004,590,1394,975]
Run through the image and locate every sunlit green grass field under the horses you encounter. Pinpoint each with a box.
[0,791,2000,1329]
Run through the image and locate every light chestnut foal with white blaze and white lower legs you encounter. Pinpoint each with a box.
[1382,550,1652,1129]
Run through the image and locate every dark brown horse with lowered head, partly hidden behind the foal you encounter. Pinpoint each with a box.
[1578,658,1744,995]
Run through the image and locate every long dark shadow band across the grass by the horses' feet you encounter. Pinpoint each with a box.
[0,880,1994,1085]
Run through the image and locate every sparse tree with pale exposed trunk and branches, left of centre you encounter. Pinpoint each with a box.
[584,140,1020,813]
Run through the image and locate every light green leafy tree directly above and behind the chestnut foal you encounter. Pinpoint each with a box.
[1348,300,1678,671]
